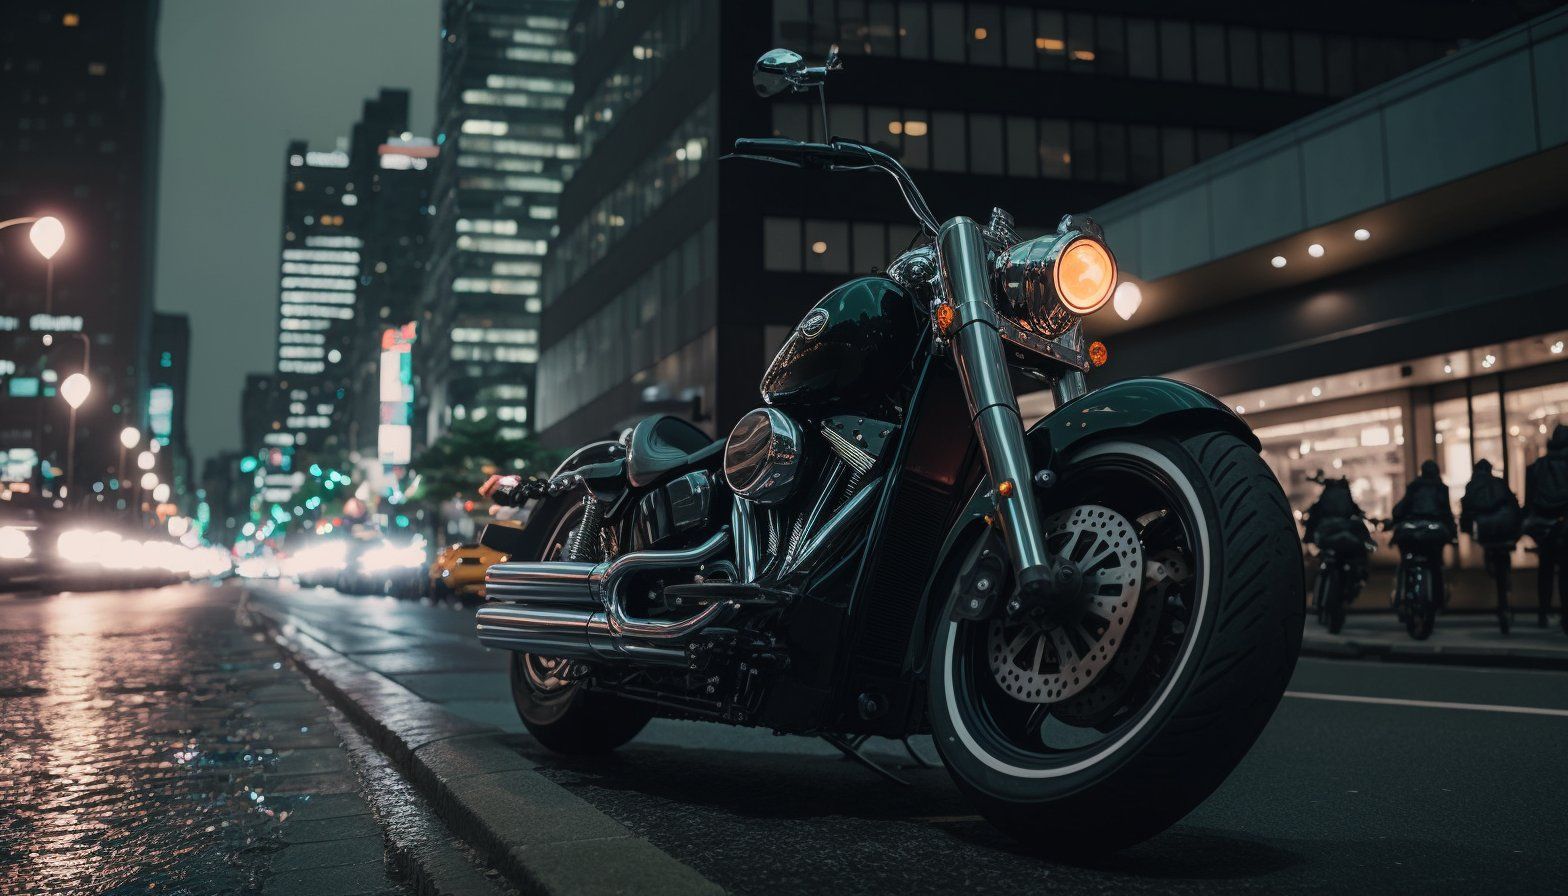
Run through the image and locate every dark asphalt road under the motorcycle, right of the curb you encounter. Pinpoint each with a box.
[252,585,1568,894]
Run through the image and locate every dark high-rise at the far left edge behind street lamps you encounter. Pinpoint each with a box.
[0,0,162,494]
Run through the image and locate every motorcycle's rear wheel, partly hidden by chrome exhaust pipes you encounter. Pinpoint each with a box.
[511,502,654,753]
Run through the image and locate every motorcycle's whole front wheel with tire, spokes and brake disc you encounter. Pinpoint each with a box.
[928,433,1305,854]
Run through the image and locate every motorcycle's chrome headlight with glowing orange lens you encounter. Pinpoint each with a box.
[996,215,1116,336]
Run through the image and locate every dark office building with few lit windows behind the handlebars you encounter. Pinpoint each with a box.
[536,0,1530,447]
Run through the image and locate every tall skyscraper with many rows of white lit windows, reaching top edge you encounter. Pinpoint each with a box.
[416,0,577,436]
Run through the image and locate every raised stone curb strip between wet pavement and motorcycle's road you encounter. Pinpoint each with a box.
[246,604,723,896]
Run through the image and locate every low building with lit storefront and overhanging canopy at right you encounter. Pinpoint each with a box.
[1053,11,1568,603]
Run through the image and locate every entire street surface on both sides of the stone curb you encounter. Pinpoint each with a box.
[0,584,1568,893]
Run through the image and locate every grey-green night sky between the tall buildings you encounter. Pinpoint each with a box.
[155,0,441,463]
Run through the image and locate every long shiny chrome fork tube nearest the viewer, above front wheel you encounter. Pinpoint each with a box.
[936,217,1052,588]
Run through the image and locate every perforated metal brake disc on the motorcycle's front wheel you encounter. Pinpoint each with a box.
[986,504,1143,703]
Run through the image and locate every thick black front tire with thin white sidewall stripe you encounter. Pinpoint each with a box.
[927,432,1306,855]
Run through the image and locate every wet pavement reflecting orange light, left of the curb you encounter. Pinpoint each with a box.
[0,584,403,896]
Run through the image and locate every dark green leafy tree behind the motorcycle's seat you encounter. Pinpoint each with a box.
[409,417,564,504]
